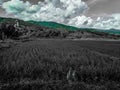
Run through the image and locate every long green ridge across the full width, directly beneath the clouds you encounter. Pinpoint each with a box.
[0,17,120,35]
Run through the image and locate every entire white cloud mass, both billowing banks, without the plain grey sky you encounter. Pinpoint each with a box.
[2,0,120,29]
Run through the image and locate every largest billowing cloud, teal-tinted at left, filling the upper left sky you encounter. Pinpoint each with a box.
[2,0,88,22]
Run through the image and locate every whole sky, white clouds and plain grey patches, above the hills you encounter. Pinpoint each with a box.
[0,0,120,29]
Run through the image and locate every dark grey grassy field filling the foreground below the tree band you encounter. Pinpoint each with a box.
[0,39,120,90]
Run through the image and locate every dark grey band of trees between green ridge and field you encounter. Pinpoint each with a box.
[0,21,120,39]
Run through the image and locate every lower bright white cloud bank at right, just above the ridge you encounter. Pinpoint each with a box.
[69,14,120,29]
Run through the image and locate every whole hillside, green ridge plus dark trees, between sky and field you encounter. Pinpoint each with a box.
[0,18,120,39]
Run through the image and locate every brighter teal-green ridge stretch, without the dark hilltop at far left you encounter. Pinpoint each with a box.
[29,21,120,35]
